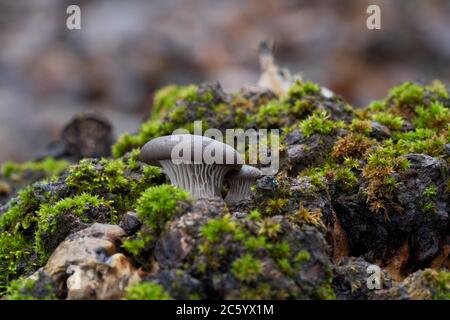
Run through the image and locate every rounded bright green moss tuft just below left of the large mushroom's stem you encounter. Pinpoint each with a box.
[136,185,189,231]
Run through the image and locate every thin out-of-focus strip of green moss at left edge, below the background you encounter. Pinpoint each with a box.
[0,157,70,179]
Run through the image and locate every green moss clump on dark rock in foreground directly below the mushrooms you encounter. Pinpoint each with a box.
[194,211,332,299]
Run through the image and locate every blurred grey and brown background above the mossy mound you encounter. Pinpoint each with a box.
[0,0,450,161]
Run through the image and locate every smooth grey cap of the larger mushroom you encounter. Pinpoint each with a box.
[141,134,244,170]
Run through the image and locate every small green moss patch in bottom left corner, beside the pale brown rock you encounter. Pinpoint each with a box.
[6,278,57,300]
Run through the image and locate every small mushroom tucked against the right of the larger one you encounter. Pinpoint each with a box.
[225,165,262,205]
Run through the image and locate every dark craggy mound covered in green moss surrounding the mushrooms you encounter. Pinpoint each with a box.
[0,81,450,299]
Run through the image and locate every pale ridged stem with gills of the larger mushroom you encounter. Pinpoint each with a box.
[159,160,230,199]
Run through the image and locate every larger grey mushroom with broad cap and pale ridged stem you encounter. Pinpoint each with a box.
[141,134,243,199]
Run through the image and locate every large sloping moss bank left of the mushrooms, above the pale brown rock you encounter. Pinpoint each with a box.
[0,151,164,290]
